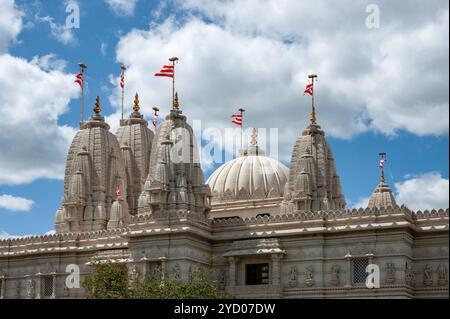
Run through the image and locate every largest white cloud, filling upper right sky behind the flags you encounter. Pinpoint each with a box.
[110,0,449,166]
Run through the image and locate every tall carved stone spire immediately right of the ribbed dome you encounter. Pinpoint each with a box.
[283,123,345,211]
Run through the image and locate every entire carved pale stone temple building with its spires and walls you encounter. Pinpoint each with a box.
[0,100,449,299]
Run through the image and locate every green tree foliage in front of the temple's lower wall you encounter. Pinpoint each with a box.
[83,263,232,299]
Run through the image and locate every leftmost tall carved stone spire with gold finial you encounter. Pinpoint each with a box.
[55,97,128,232]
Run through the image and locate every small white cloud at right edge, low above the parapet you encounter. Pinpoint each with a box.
[395,172,449,210]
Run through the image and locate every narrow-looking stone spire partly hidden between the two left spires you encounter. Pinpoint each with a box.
[116,94,154,214]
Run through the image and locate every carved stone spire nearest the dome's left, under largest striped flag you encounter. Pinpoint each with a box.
[138,105,210,216]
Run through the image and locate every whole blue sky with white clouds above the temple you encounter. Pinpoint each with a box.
[0,0,449,237]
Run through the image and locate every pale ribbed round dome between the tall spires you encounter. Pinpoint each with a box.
[207,146,289,203]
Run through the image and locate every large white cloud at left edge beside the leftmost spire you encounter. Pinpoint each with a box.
[0,54,78,184]
